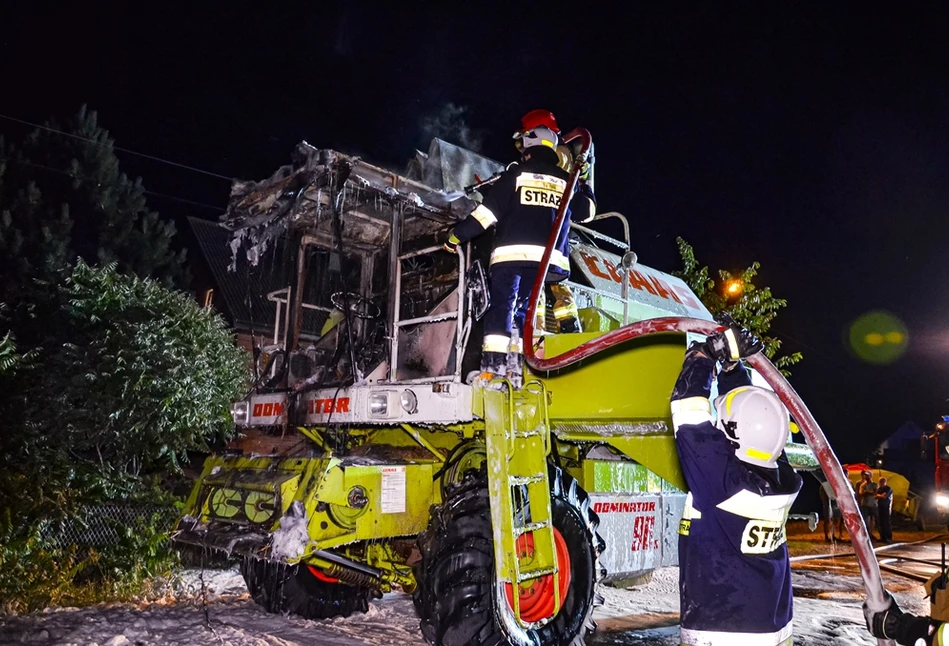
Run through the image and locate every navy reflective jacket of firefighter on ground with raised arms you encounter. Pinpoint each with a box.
[672,351,801,646]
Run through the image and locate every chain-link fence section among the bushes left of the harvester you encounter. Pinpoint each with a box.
[43,503,178,547]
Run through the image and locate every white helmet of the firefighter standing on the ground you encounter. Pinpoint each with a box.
[715,386,791,469]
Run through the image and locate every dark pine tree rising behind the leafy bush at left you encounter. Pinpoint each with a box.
[0,106,187,300]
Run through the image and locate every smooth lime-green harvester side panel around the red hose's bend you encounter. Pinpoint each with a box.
[543,333,685,424]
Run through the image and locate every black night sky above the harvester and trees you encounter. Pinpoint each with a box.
[0,2,949,459]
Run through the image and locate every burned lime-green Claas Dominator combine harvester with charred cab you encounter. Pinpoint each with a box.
[175,140,807,644]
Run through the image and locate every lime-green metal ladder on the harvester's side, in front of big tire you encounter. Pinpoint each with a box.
[484,380,563,627]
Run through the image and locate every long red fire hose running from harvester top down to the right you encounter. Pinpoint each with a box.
[524,128,894,646]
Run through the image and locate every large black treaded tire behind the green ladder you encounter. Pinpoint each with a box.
[414,467,605,646]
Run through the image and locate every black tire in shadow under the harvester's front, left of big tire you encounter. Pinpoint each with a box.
[241,557,382,619]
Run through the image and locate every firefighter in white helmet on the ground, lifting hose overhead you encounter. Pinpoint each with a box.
[672,319,802,646]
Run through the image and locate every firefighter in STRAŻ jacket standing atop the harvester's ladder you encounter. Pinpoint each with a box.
[445,111,593,379]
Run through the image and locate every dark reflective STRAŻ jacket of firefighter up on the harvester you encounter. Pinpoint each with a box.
[453,147,596,275]
